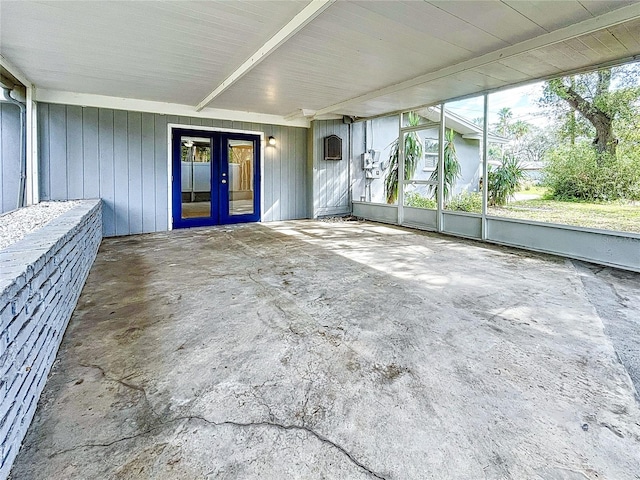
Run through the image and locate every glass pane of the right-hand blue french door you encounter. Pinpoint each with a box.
[228,140,254,215]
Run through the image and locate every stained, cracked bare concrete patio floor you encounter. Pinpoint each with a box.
[12,221,640,480]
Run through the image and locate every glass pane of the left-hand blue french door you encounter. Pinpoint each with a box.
[180,136,211,218]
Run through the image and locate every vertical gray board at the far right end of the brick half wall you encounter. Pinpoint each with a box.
[98,108,116,236]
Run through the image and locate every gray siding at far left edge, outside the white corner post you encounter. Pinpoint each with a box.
[0,102,20,213]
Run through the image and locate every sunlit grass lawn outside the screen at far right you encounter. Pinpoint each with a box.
[487,199,640,233]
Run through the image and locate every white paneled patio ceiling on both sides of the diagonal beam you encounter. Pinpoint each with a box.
[0,0,640,122]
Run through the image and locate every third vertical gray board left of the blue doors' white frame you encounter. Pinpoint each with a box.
[127,112,142,233]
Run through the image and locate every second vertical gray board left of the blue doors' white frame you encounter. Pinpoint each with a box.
[141,113,156,232]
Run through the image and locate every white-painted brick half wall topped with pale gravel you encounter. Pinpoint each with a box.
[0,200,102,480]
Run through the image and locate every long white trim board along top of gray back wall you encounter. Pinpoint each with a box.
[35,88,310,128]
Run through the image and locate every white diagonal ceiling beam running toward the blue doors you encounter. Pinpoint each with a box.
[196,0,336,112]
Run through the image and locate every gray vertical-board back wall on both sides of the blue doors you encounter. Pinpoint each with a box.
[38,103,308,236]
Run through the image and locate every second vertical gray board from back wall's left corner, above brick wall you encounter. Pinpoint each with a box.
[49,105,71,200]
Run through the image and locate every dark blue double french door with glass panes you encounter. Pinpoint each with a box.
[172,128,260,228]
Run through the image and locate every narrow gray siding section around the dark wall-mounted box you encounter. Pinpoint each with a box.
[311,120,351,217]
